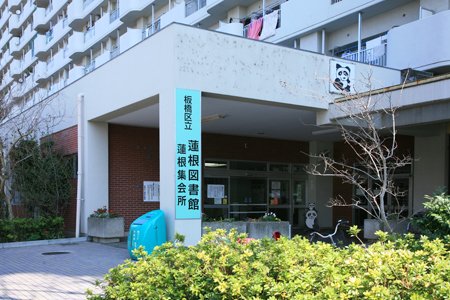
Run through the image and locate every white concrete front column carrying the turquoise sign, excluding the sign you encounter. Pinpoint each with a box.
[159,88,201,245]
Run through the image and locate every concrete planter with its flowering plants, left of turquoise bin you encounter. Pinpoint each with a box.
[88,206,125,243]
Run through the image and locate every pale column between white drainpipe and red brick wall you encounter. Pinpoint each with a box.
[78,122,109,234]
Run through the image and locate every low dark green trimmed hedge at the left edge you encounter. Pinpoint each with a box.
[0,216,65,243]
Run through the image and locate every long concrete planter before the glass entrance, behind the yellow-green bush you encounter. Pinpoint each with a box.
[202,221,289,239]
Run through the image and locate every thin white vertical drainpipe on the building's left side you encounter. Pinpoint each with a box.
[75,93,84,237]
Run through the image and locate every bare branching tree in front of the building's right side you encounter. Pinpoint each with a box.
[282,69,413,235]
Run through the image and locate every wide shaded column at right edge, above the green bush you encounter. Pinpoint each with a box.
[412,123,449,212]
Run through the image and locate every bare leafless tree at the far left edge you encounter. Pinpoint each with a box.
[0,80,63,220]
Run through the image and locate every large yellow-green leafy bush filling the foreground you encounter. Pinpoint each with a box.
[87,230,450,300]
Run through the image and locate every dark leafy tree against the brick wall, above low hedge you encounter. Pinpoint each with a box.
[12,135,74,218]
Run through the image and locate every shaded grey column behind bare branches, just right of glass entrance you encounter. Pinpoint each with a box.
[308,141,333,227]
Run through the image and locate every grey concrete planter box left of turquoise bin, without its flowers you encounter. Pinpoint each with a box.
[88,217,125,243]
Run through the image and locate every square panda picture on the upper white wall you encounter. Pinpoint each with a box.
[330,59,356,94]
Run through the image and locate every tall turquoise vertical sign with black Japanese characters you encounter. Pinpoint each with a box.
[175,89,202,219]
